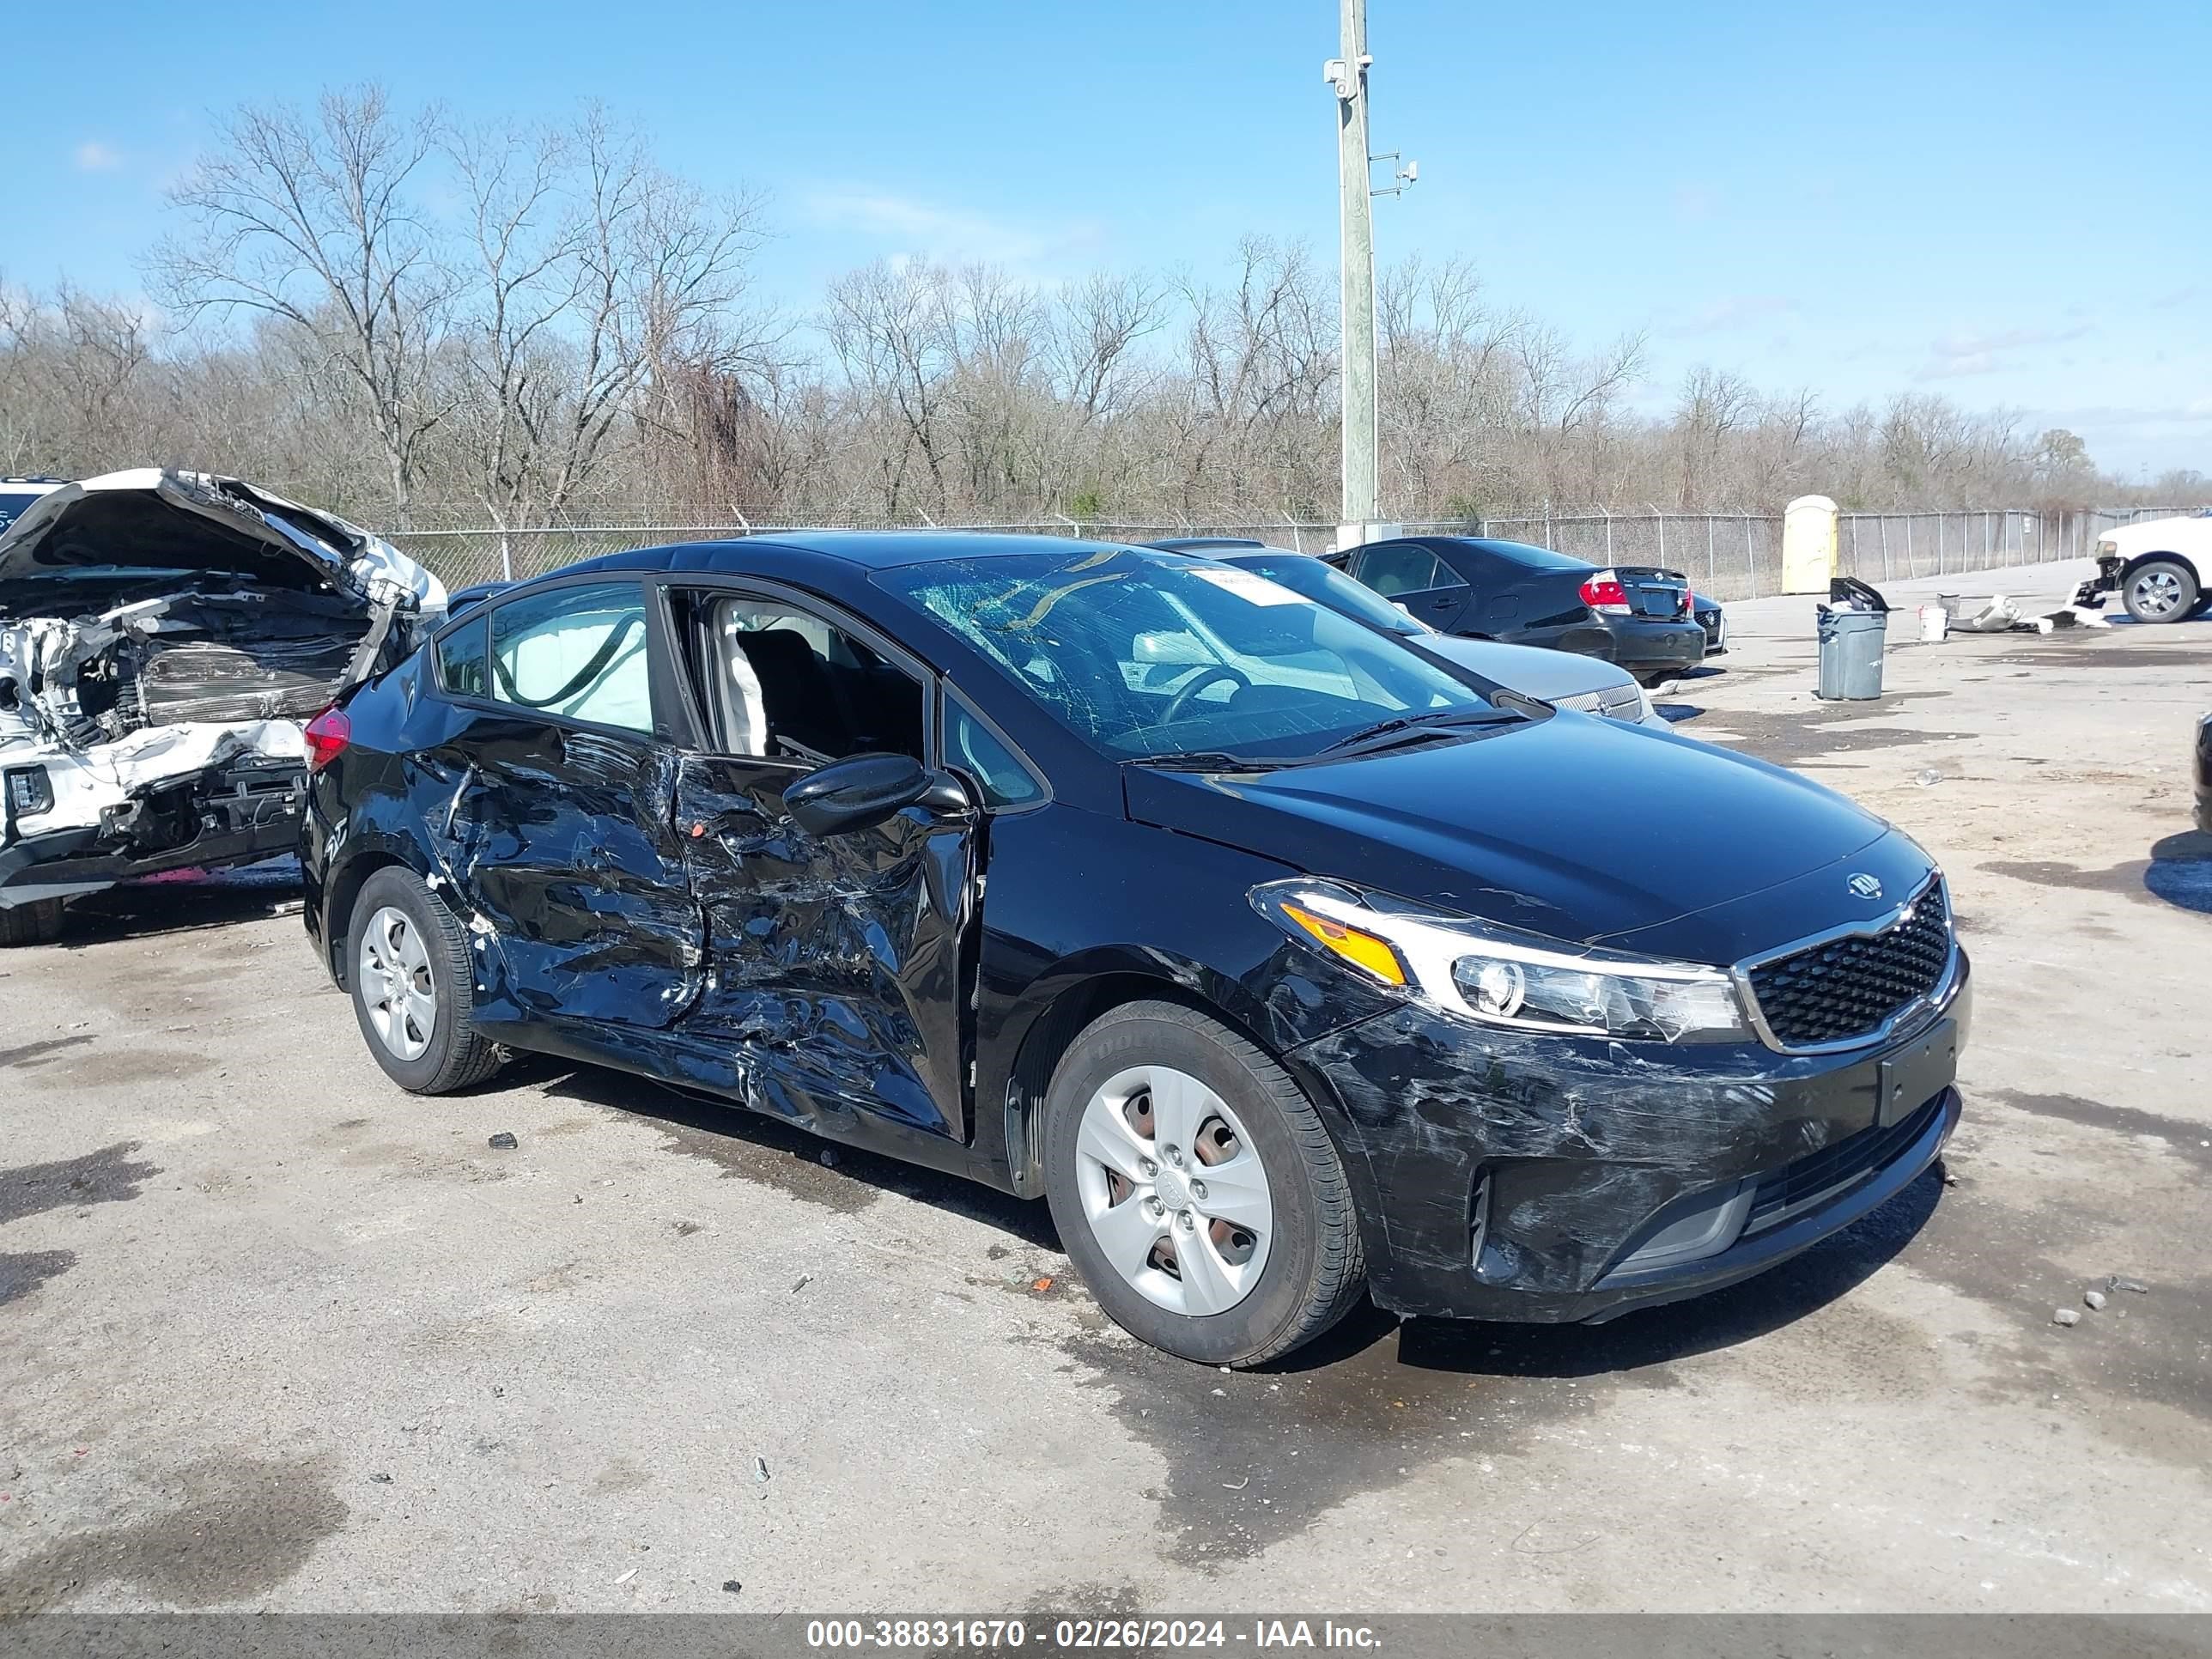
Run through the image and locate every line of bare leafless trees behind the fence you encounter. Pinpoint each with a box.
[0,86,2212,529]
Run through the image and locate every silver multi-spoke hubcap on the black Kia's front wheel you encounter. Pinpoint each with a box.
[1075,1066,1274,1318]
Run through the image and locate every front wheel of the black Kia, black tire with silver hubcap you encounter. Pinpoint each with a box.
[1044,1002,1367,1364]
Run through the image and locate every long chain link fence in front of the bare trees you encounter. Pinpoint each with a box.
[387,507,2205,599]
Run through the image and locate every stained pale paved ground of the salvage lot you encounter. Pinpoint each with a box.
[0,555,2212,1613]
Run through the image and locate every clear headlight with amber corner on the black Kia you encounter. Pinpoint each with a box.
[1252,880,1754,1042]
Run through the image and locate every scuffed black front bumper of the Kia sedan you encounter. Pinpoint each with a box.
[1294,953,1971,1325]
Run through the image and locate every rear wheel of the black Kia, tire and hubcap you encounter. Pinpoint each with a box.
[345,865,504,1095]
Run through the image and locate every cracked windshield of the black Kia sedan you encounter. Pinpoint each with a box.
[876,549,1504,763]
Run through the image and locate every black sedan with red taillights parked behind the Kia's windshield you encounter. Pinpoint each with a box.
[1329,535,1705,684]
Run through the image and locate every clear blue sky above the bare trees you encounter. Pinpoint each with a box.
[0,0,2212,476]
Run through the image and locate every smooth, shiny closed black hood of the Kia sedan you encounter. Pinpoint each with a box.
[1124,712,1902,963]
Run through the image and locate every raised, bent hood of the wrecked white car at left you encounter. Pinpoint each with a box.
[0,467,445,617]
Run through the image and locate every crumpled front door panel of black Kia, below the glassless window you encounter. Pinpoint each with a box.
[677,757,975,1141]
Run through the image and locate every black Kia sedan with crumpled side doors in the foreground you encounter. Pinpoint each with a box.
[303,533,1966,1364]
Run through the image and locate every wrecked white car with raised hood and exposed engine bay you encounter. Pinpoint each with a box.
[0,467,445,945]
